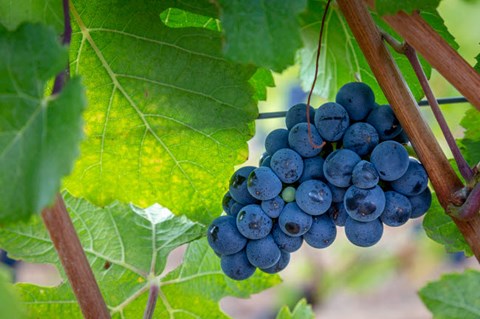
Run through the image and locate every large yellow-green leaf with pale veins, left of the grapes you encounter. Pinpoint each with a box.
[65,0,258,224]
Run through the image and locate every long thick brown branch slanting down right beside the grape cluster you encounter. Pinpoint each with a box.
[337,0,480,260]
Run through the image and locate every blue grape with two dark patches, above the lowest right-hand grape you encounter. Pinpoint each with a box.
[344,185,385,222]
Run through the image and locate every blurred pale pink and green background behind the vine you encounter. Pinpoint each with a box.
[0,0,480,319]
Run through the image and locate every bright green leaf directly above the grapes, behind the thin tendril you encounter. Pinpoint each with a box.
[297,0,431,104]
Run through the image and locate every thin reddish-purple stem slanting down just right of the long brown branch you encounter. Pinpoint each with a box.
[381,31,473,183]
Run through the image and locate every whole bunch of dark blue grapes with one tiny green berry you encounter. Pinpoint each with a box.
[207,83,432,280]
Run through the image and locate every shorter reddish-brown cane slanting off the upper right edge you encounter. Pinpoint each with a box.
[366,0,480,110]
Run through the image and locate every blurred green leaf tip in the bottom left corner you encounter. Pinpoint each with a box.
[0,267,26,319]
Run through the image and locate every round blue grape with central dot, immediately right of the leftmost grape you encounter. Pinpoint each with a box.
[237,205,272,239]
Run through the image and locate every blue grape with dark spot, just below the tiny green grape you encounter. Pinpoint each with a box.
[278,203,312,237]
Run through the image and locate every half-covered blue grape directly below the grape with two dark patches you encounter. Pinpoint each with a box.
[345,217,383,247]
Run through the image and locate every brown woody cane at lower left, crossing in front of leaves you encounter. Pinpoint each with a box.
[42,194,110,319]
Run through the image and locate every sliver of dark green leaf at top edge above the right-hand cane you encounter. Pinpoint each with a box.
[375,0,440,16]
